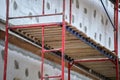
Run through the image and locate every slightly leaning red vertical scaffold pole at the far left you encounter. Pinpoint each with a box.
[3,0,9,80]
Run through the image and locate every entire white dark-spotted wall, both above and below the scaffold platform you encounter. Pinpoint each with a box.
[0,0,120,80]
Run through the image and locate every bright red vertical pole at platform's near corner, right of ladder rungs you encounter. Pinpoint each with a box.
[61,0,65,80]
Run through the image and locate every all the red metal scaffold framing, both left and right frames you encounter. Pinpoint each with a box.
[3,0,119,80]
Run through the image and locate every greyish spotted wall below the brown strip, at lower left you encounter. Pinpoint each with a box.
[0,41,90,80]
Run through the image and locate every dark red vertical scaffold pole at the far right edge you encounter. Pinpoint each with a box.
[114,0,119,80]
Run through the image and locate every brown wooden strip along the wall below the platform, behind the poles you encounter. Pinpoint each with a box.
[0,30,98,80]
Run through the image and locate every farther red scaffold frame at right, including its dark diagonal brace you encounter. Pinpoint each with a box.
[68,0,120,80]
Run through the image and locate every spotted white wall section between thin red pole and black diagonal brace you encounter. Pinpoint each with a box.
[70,0,113,50]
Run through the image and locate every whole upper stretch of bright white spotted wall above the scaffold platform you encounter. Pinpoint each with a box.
[0,0,120,57]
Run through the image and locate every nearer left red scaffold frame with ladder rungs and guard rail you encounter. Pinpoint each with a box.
[3,0,65,80]
